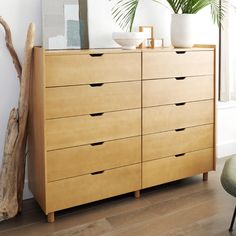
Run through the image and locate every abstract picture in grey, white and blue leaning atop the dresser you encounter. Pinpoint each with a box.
[42,0,89,50]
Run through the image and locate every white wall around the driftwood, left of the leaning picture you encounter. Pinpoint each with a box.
[0,0,41,198]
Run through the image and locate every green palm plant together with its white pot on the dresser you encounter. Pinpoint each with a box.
[111,0,227,47]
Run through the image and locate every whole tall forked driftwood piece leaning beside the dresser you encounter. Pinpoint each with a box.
[0,17,35,221]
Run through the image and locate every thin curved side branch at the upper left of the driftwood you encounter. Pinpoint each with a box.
[0,16,22,79]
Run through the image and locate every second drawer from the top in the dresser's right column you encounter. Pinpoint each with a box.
[143,76,214,107]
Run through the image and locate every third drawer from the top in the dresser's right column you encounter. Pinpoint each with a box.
[143,100,214,134]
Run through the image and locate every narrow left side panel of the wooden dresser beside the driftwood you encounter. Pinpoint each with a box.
[28,48,47,211]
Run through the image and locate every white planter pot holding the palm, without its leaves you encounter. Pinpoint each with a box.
[171,14,196,48]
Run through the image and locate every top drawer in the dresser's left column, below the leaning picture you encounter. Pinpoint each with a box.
[45,53,141,87]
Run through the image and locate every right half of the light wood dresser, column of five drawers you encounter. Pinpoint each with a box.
[142,48,215,188]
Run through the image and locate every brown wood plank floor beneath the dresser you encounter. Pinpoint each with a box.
[0,157,236,236]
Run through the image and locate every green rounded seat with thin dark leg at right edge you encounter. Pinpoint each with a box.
[221,156,236,232]
